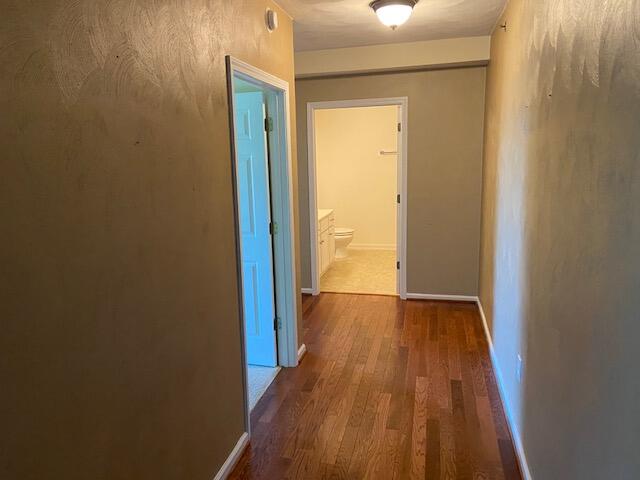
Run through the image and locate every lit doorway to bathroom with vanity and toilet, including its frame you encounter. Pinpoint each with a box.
[307,98,407,298]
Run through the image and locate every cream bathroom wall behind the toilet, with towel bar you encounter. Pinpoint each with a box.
[315,106,399,249]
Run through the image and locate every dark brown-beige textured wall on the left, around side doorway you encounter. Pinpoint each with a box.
[0,0,295,480]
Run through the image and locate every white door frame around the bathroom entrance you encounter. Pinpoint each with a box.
[307,97,409,299]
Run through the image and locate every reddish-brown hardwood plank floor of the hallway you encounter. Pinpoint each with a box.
[230,293,521,480]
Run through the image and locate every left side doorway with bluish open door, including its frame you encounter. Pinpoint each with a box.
[227,57,298,429]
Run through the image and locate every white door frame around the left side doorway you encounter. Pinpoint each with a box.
[226,56,298,433]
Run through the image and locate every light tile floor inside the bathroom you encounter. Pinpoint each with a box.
[320,249,397,295]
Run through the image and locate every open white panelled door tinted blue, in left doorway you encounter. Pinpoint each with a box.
[234,92,277,367]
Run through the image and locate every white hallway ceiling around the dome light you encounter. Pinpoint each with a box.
[278,0,506,51]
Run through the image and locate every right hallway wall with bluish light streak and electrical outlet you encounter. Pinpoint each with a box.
[480,0,640,480]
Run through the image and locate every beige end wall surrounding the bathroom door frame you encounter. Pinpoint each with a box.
[296,67,485,296]
